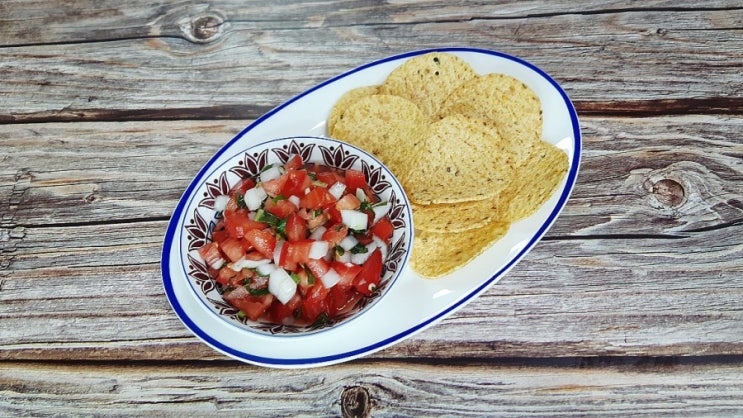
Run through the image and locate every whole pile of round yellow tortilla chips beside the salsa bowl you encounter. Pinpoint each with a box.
[328,52,568,278]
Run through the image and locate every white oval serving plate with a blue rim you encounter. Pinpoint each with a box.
[161,48,581,368]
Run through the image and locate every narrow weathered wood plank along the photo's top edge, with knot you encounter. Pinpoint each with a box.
[0,0,740,47]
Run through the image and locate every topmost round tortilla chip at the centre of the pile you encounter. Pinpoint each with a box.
[400,115,513,205]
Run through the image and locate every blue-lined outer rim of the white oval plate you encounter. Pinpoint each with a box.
[161,47,581,367]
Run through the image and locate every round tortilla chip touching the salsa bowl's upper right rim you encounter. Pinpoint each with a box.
[330,94,428,177]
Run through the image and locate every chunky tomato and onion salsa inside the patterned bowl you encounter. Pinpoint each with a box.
[198,155,394,325]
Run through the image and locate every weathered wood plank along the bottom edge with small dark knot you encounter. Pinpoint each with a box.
[0,360,743,417]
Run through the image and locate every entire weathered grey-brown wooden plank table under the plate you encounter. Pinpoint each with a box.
[0,0,743,416]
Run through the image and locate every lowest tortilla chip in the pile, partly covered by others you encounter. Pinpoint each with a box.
[410,221,509,279]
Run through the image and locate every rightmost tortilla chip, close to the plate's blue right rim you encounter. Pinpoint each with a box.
[504,141,568,222]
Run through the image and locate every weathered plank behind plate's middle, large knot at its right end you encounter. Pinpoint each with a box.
[0,116,743,236]
